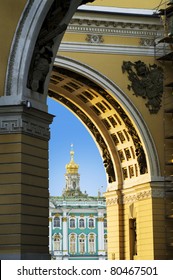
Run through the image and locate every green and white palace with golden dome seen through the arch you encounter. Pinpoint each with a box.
[49,150,107,260]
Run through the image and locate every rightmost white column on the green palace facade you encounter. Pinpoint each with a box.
[97,210,105,259]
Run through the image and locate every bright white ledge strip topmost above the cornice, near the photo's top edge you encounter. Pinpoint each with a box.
[77,5,156,16]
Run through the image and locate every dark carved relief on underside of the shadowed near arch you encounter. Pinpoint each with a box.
[27,0,94,94]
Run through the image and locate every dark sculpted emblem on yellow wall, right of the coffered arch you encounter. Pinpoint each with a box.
[122,60,163,114]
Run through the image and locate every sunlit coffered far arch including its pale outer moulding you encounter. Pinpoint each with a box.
[48,57,159,189]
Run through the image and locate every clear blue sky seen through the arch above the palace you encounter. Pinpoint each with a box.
[47,98,107,196]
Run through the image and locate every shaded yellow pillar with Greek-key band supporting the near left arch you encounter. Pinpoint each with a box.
[0,106,53,259]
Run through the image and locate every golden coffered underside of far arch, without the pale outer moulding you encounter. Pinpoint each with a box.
[48,62,149,189]
